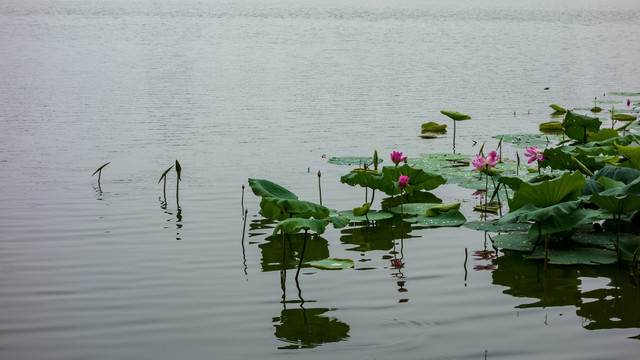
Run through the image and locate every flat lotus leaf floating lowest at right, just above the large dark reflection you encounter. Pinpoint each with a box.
[524,247,618,265]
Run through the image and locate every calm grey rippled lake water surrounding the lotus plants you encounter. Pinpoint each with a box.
[0,0,640,359]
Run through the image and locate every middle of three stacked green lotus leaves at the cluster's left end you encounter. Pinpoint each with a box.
[260,197,330,220]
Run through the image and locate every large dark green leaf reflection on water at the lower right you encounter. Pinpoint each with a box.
[492,252,640,330]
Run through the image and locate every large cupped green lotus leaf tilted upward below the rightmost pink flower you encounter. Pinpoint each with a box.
[509,172,586,211]
